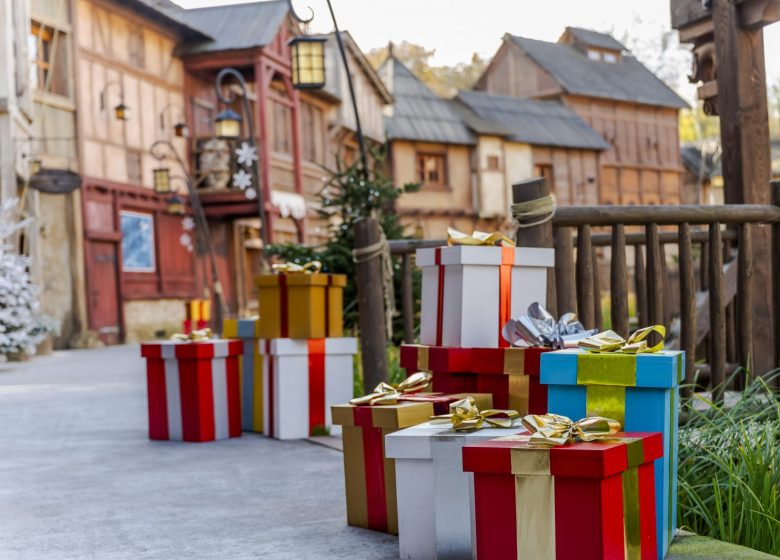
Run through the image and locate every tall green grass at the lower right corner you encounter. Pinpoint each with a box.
[678,374,780,555]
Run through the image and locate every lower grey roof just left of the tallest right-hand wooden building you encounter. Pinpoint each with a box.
[456,91,609,150]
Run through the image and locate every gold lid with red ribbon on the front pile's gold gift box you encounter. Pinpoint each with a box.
[330,401,433,430]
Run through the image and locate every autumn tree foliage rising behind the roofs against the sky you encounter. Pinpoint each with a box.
[366,41,489,97]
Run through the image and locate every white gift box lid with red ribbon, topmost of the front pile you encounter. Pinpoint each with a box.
[416,245,555,267]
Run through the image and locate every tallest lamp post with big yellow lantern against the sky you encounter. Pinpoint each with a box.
[287,0,368,178]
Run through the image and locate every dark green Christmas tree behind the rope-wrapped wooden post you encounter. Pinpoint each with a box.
[268,154,419,344]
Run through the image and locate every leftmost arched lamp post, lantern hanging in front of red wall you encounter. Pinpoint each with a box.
[149,140,223,333]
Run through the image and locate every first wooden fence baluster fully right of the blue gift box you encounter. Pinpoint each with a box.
[709,224,726,401]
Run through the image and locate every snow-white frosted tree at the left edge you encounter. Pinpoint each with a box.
[0,199,58,355]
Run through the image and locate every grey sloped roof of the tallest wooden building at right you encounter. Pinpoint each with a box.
[505,35,688,109]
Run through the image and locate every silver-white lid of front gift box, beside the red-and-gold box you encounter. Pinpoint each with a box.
[385,420,523,459]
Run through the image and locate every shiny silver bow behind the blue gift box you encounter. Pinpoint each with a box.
[501,302,598,349]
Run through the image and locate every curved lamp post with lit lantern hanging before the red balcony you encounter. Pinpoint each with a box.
[214,68,268,269]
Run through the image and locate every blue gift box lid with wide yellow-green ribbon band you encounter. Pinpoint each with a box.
[541,349,685,388]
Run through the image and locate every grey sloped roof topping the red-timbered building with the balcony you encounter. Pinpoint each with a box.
[180,0,288,54]
